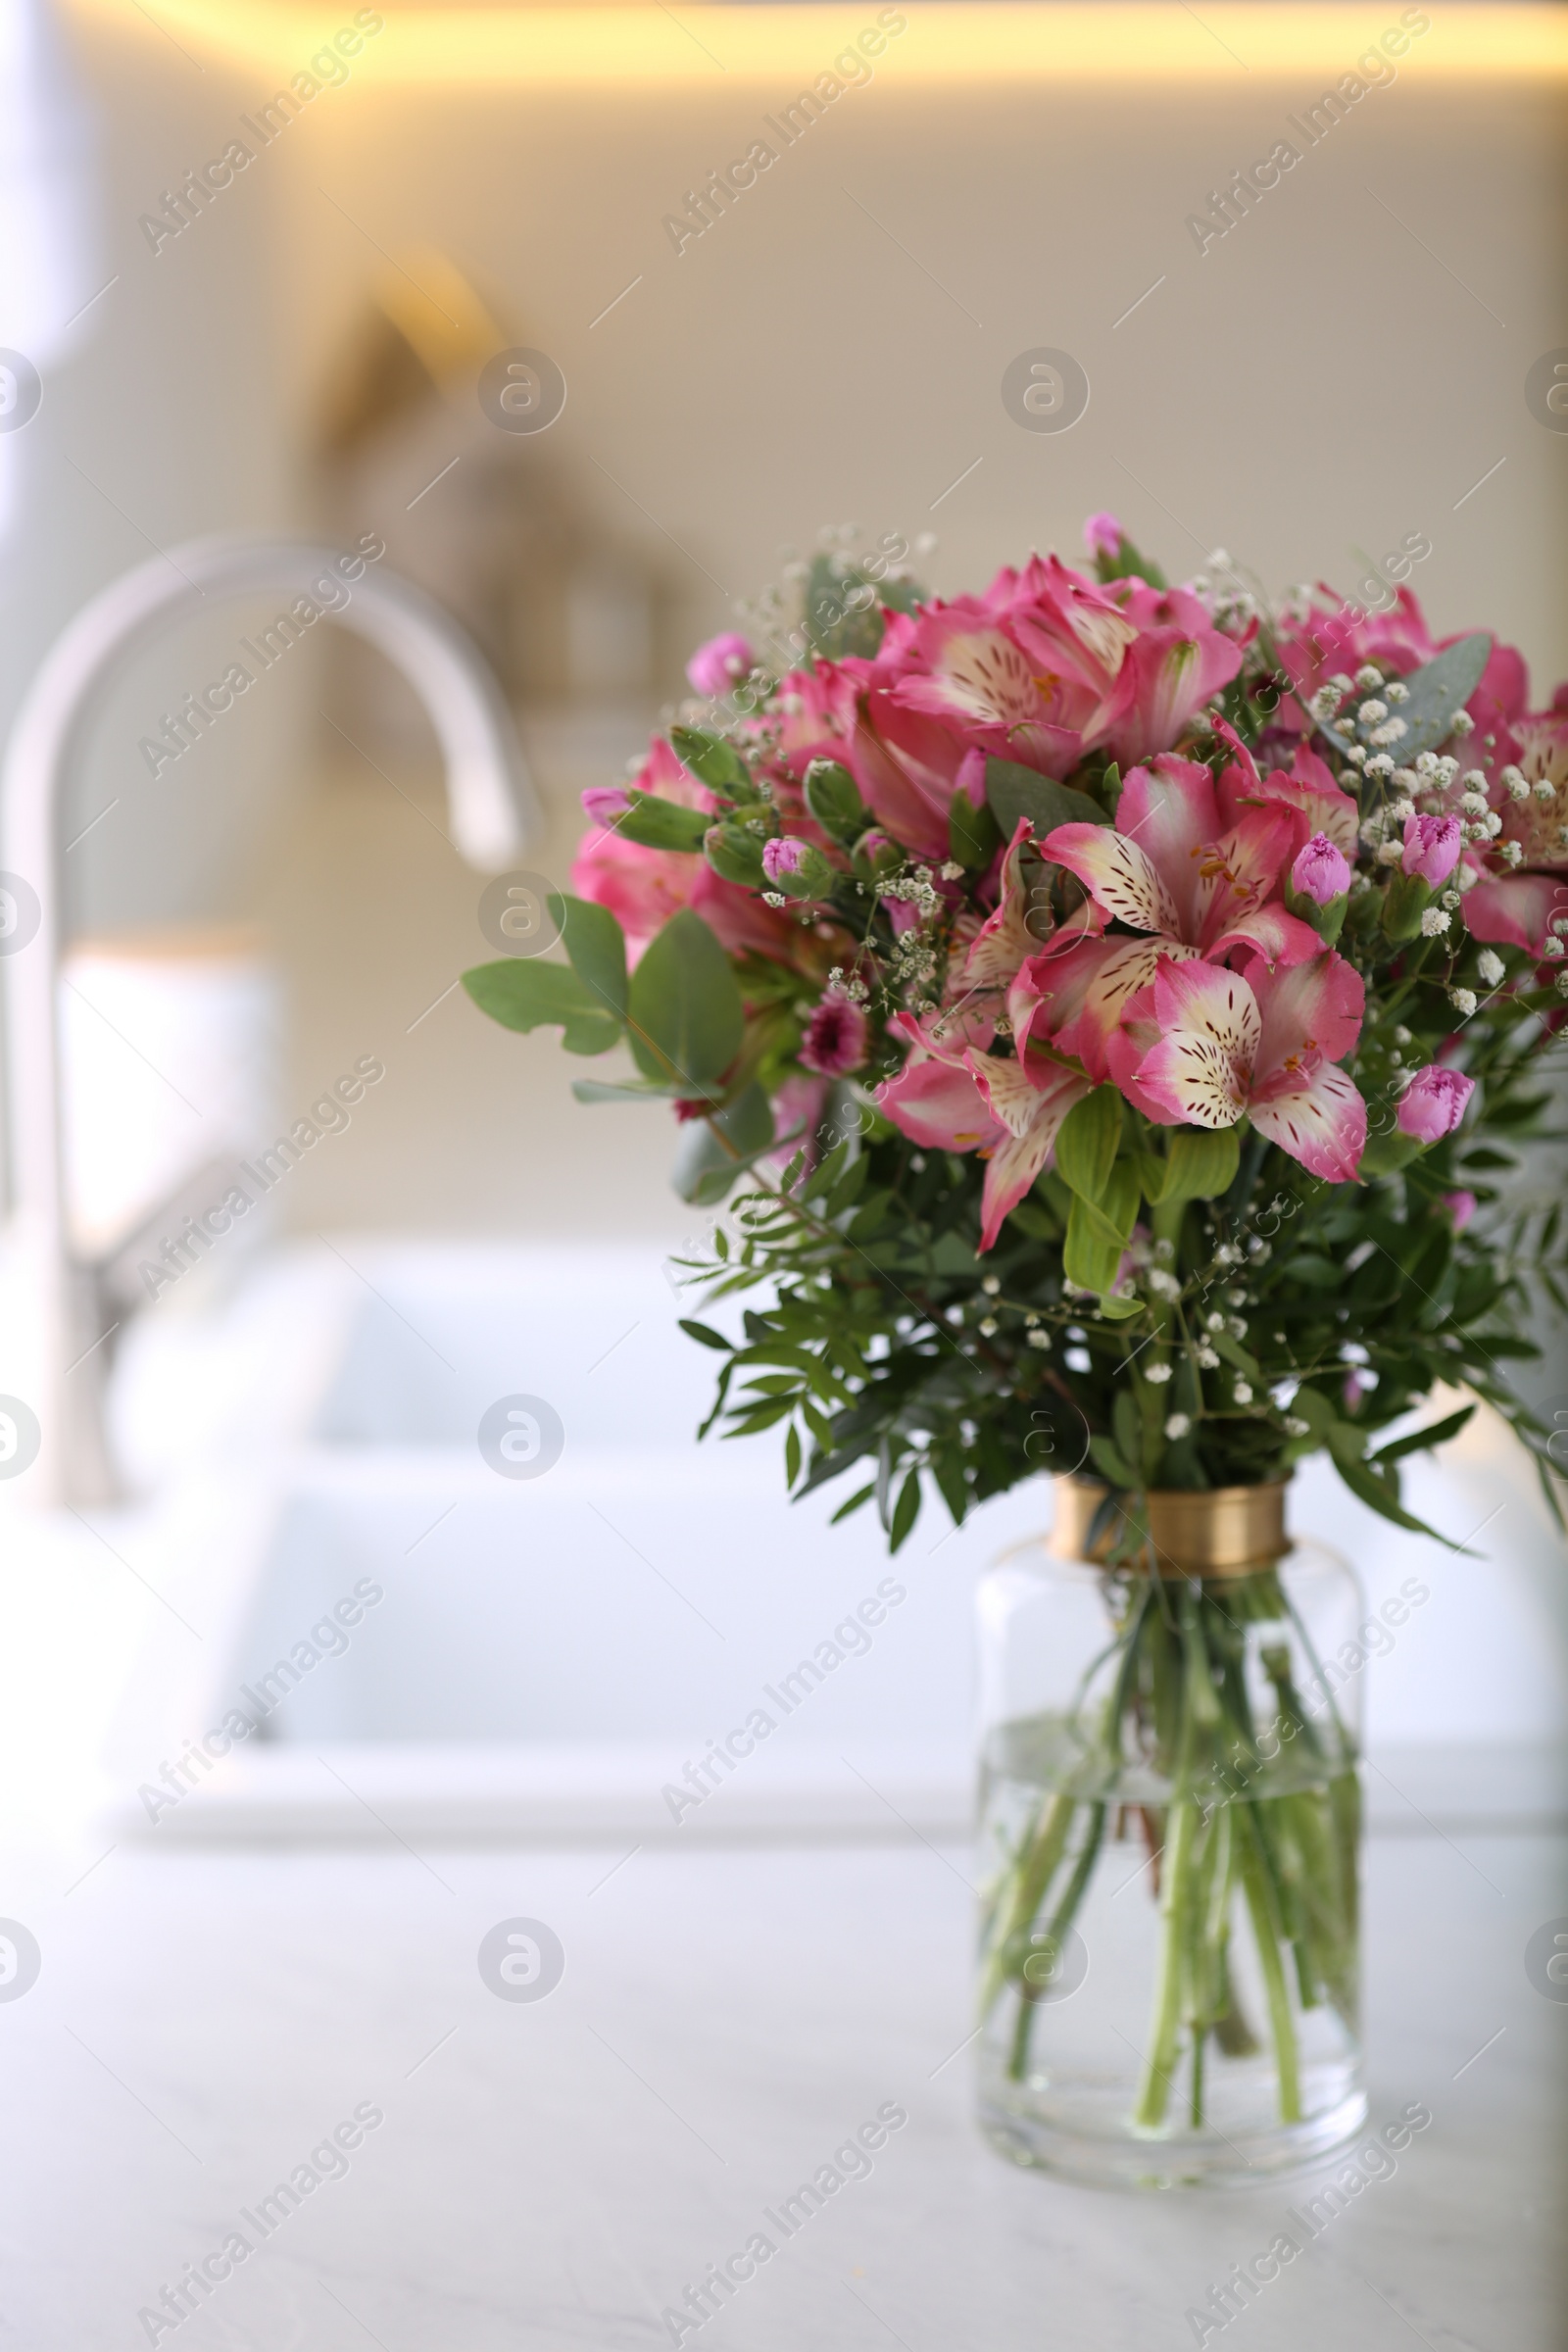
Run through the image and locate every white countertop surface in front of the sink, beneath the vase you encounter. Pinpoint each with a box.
[0,1828,1568,2352]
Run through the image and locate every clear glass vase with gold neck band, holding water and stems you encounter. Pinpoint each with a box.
[978,1480,1366,2187]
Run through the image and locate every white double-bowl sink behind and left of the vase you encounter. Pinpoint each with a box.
[104,1242,1062,1839]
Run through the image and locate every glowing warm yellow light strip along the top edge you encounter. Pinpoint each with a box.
[73,0,1568,94]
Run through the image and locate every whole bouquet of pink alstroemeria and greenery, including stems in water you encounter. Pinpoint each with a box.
[466,515,1568,2178]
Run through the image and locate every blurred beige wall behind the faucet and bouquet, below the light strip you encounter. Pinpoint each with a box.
[21,7,1568,1235]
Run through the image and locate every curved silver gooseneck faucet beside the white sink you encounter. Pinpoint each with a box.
[0,536,538,1503]
